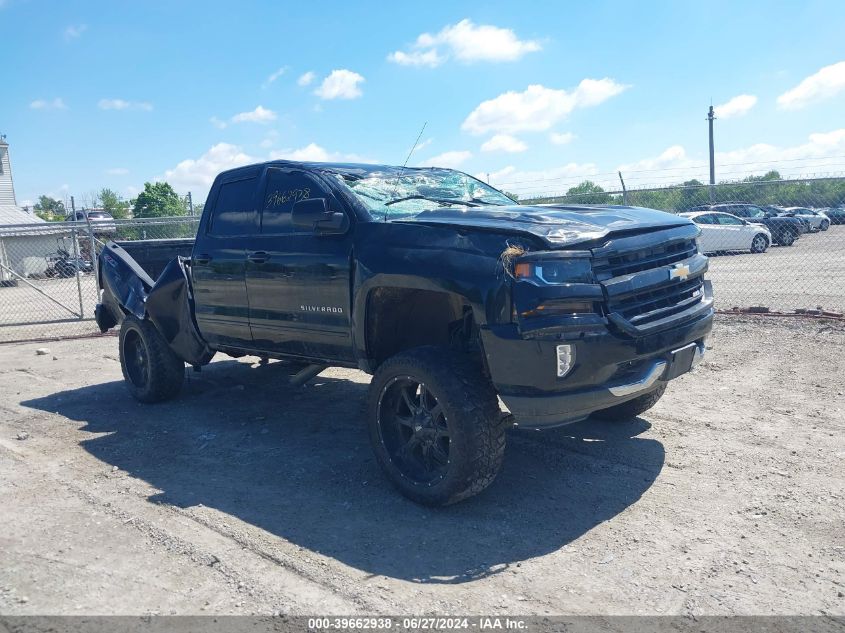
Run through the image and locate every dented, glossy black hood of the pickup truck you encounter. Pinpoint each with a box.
[391,205,691,248]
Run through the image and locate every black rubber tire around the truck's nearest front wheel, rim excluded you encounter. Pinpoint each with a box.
[367,346,504,506]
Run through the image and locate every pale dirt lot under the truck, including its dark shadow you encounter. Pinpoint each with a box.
[0,318,845,615]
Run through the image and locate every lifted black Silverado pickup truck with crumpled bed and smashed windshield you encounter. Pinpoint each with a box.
[96,161,713,505]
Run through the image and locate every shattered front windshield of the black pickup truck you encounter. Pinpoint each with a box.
[335,169,516,220]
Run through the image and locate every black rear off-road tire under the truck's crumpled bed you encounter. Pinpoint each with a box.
[119,315,185,403]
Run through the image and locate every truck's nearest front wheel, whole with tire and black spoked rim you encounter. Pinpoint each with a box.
[367,347,507,506]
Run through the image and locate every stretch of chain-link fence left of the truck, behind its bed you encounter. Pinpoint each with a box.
[0,216,199,342]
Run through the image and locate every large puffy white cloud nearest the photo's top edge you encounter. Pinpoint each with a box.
[387,19,541,68]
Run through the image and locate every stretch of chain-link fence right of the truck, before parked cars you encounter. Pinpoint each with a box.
[521,178,845,313]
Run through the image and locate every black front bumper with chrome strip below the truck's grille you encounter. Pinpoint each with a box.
[482,298,713,428]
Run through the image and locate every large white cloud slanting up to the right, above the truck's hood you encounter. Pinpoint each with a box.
[461,77,628,134]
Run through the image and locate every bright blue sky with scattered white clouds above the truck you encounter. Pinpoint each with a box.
[0,0,845,204]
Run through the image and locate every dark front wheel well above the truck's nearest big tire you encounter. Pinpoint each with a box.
[366,288,480,369]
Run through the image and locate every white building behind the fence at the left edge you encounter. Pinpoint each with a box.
[0,136,67,282]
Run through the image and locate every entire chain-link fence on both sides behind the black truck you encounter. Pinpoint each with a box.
[0,178,845,342]
